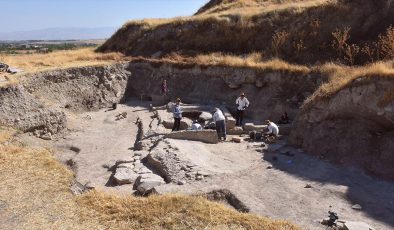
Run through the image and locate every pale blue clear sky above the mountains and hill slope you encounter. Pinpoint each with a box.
[0,0,208,32]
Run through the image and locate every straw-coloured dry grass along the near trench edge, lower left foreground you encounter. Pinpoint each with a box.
[0,129,298,230]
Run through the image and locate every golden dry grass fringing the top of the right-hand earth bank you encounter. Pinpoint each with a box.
[303,62,394,108]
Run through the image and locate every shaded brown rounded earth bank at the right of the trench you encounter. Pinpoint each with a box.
[291,78,394,179]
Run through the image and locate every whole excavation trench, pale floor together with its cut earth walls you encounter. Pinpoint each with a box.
[0,62,394,229]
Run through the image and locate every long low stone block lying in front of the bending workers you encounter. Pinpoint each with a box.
[166,130,219,144]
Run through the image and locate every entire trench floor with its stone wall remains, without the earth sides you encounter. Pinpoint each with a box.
[17,101,394,229]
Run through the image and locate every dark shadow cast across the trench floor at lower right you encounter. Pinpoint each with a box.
[262,148,394,227]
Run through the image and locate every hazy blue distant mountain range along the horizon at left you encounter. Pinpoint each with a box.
[0,27,116,41]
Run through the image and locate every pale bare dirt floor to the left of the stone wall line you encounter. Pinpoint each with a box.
[55,101,151,192]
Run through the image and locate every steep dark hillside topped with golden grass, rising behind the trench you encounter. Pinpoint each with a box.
[98,0,394,65]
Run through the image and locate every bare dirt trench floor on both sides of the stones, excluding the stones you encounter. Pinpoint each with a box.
[30,102,394,230]
